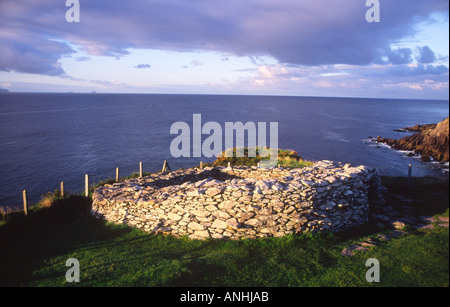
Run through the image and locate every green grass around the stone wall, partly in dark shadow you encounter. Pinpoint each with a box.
[0,172,449,287]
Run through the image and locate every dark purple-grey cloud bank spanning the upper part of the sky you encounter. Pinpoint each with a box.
[0,0,448,75]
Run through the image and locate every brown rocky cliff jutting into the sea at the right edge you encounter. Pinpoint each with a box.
[376,117,449,162]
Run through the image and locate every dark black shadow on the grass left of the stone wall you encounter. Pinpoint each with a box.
[0,195,135,286]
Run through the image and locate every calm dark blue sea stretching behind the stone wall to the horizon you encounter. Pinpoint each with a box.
[0,93,449,207]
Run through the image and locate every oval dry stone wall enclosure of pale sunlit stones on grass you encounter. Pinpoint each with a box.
[92,161,383,239]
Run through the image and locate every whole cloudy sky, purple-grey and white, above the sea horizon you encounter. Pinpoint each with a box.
[0,0,449,99]
